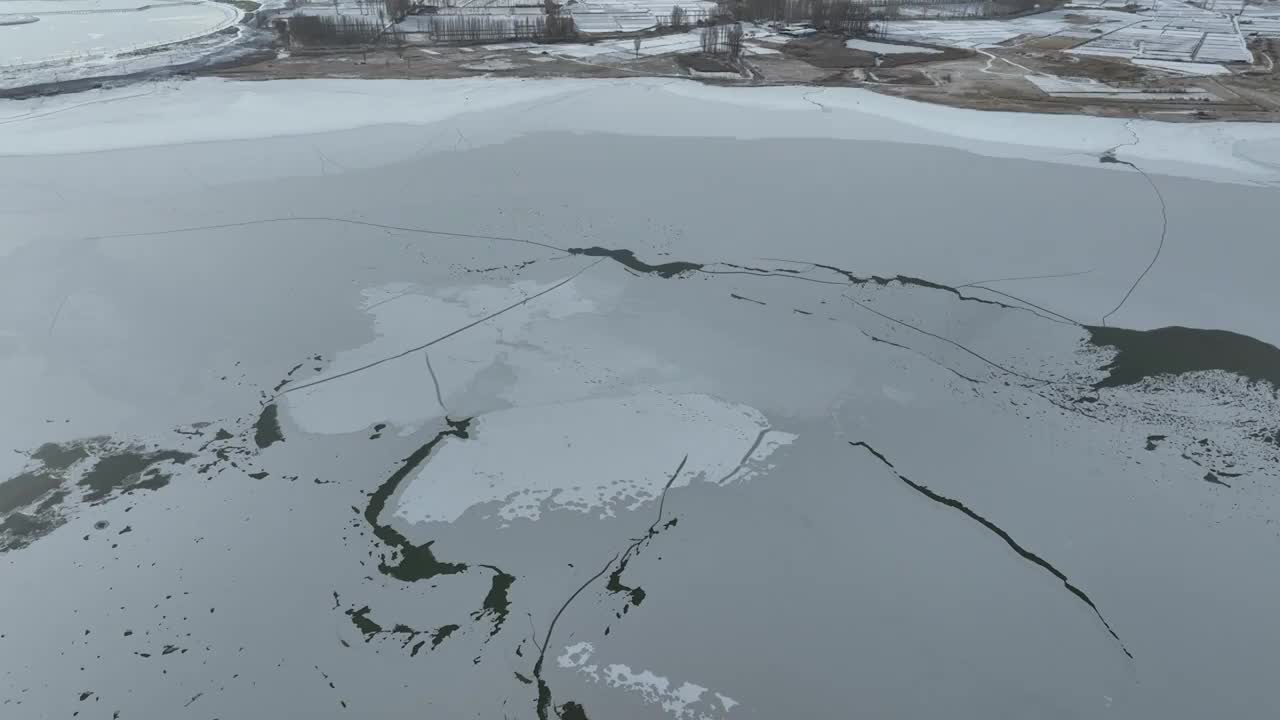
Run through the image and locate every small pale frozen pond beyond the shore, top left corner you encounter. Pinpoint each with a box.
[0,0,239,68]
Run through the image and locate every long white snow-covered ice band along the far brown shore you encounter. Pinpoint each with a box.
[0,78,1280,183]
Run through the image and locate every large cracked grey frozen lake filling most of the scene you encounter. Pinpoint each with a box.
[0,81,1280,720]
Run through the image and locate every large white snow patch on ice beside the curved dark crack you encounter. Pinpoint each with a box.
[396,393,794,524]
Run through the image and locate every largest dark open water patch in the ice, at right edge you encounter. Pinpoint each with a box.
[1084,325,1280,392]
